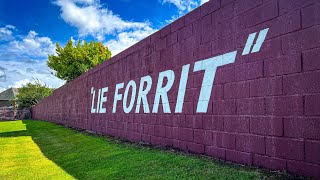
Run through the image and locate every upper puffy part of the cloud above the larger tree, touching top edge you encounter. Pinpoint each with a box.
[55,0,154,41]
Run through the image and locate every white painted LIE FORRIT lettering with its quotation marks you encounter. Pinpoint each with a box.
[91,28,269,113]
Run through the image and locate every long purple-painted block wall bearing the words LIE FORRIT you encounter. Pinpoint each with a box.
[32,0,320,178]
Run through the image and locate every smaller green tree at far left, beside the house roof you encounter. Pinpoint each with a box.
[16,79,54,109]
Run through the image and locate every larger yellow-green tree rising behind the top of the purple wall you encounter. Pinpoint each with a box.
[47,39,111,81]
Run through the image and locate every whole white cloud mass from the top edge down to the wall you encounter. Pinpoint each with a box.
[55,0,156,55]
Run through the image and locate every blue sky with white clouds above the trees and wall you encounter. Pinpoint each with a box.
[0,0,207,92]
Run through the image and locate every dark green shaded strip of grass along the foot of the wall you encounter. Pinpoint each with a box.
[0,120,306,179]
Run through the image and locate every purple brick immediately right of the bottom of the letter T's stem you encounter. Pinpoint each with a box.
[212,99,236,115]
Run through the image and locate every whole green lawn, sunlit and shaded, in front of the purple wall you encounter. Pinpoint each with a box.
[0,120,300,179]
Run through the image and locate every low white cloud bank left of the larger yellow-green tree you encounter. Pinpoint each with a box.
[0,25,64,90]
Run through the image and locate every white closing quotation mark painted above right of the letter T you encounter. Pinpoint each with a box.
[242,28,269,55]
